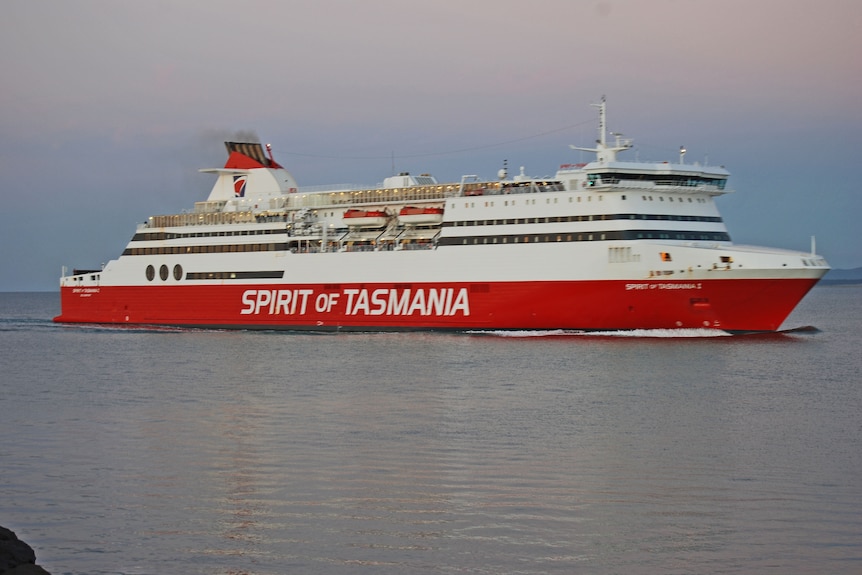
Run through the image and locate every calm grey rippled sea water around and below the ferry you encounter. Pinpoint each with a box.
[0,286,862,575]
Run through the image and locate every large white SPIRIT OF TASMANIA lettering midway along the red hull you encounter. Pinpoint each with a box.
[240,287,470,317]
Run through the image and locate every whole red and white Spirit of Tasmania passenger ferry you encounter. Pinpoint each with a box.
[54,98,829,333]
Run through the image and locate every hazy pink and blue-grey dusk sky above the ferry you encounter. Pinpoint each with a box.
[0,0,862,291]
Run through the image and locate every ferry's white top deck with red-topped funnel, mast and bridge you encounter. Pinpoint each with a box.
[150,99,729,228]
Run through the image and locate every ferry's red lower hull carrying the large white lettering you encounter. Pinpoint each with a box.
[54,279,817,331]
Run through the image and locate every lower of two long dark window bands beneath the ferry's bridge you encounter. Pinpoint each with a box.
[437,230,730,246]
